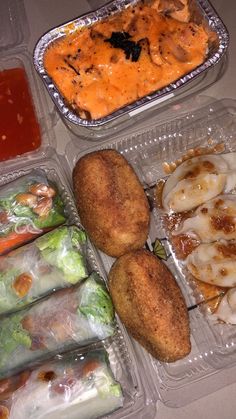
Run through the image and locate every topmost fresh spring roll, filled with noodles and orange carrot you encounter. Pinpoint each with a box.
[0,169,65,254]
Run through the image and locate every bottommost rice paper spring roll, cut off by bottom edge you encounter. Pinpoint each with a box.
[0,350,123,419]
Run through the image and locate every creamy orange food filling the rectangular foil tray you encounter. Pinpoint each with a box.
[44,0,210,120]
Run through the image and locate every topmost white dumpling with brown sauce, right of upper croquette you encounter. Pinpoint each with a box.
[162,153,236,212]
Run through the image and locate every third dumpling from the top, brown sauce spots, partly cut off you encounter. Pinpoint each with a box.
[186,241,236,287]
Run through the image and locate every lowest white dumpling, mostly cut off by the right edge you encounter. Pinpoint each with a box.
[214,288,236,324]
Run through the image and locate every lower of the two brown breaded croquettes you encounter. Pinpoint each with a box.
[109,249,191,362]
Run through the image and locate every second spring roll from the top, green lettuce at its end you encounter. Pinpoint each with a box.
[0,226,87,313]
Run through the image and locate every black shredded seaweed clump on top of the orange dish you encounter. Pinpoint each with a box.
[104,32,142,62]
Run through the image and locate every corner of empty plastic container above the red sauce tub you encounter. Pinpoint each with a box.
[0,0,29,52]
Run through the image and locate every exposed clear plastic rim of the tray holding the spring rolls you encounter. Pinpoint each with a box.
[0,151,157,418]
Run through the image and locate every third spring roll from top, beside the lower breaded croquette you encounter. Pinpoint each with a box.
[0,272,115,378]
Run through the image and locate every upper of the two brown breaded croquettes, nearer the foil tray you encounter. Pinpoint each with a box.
[73,150,150,257]
